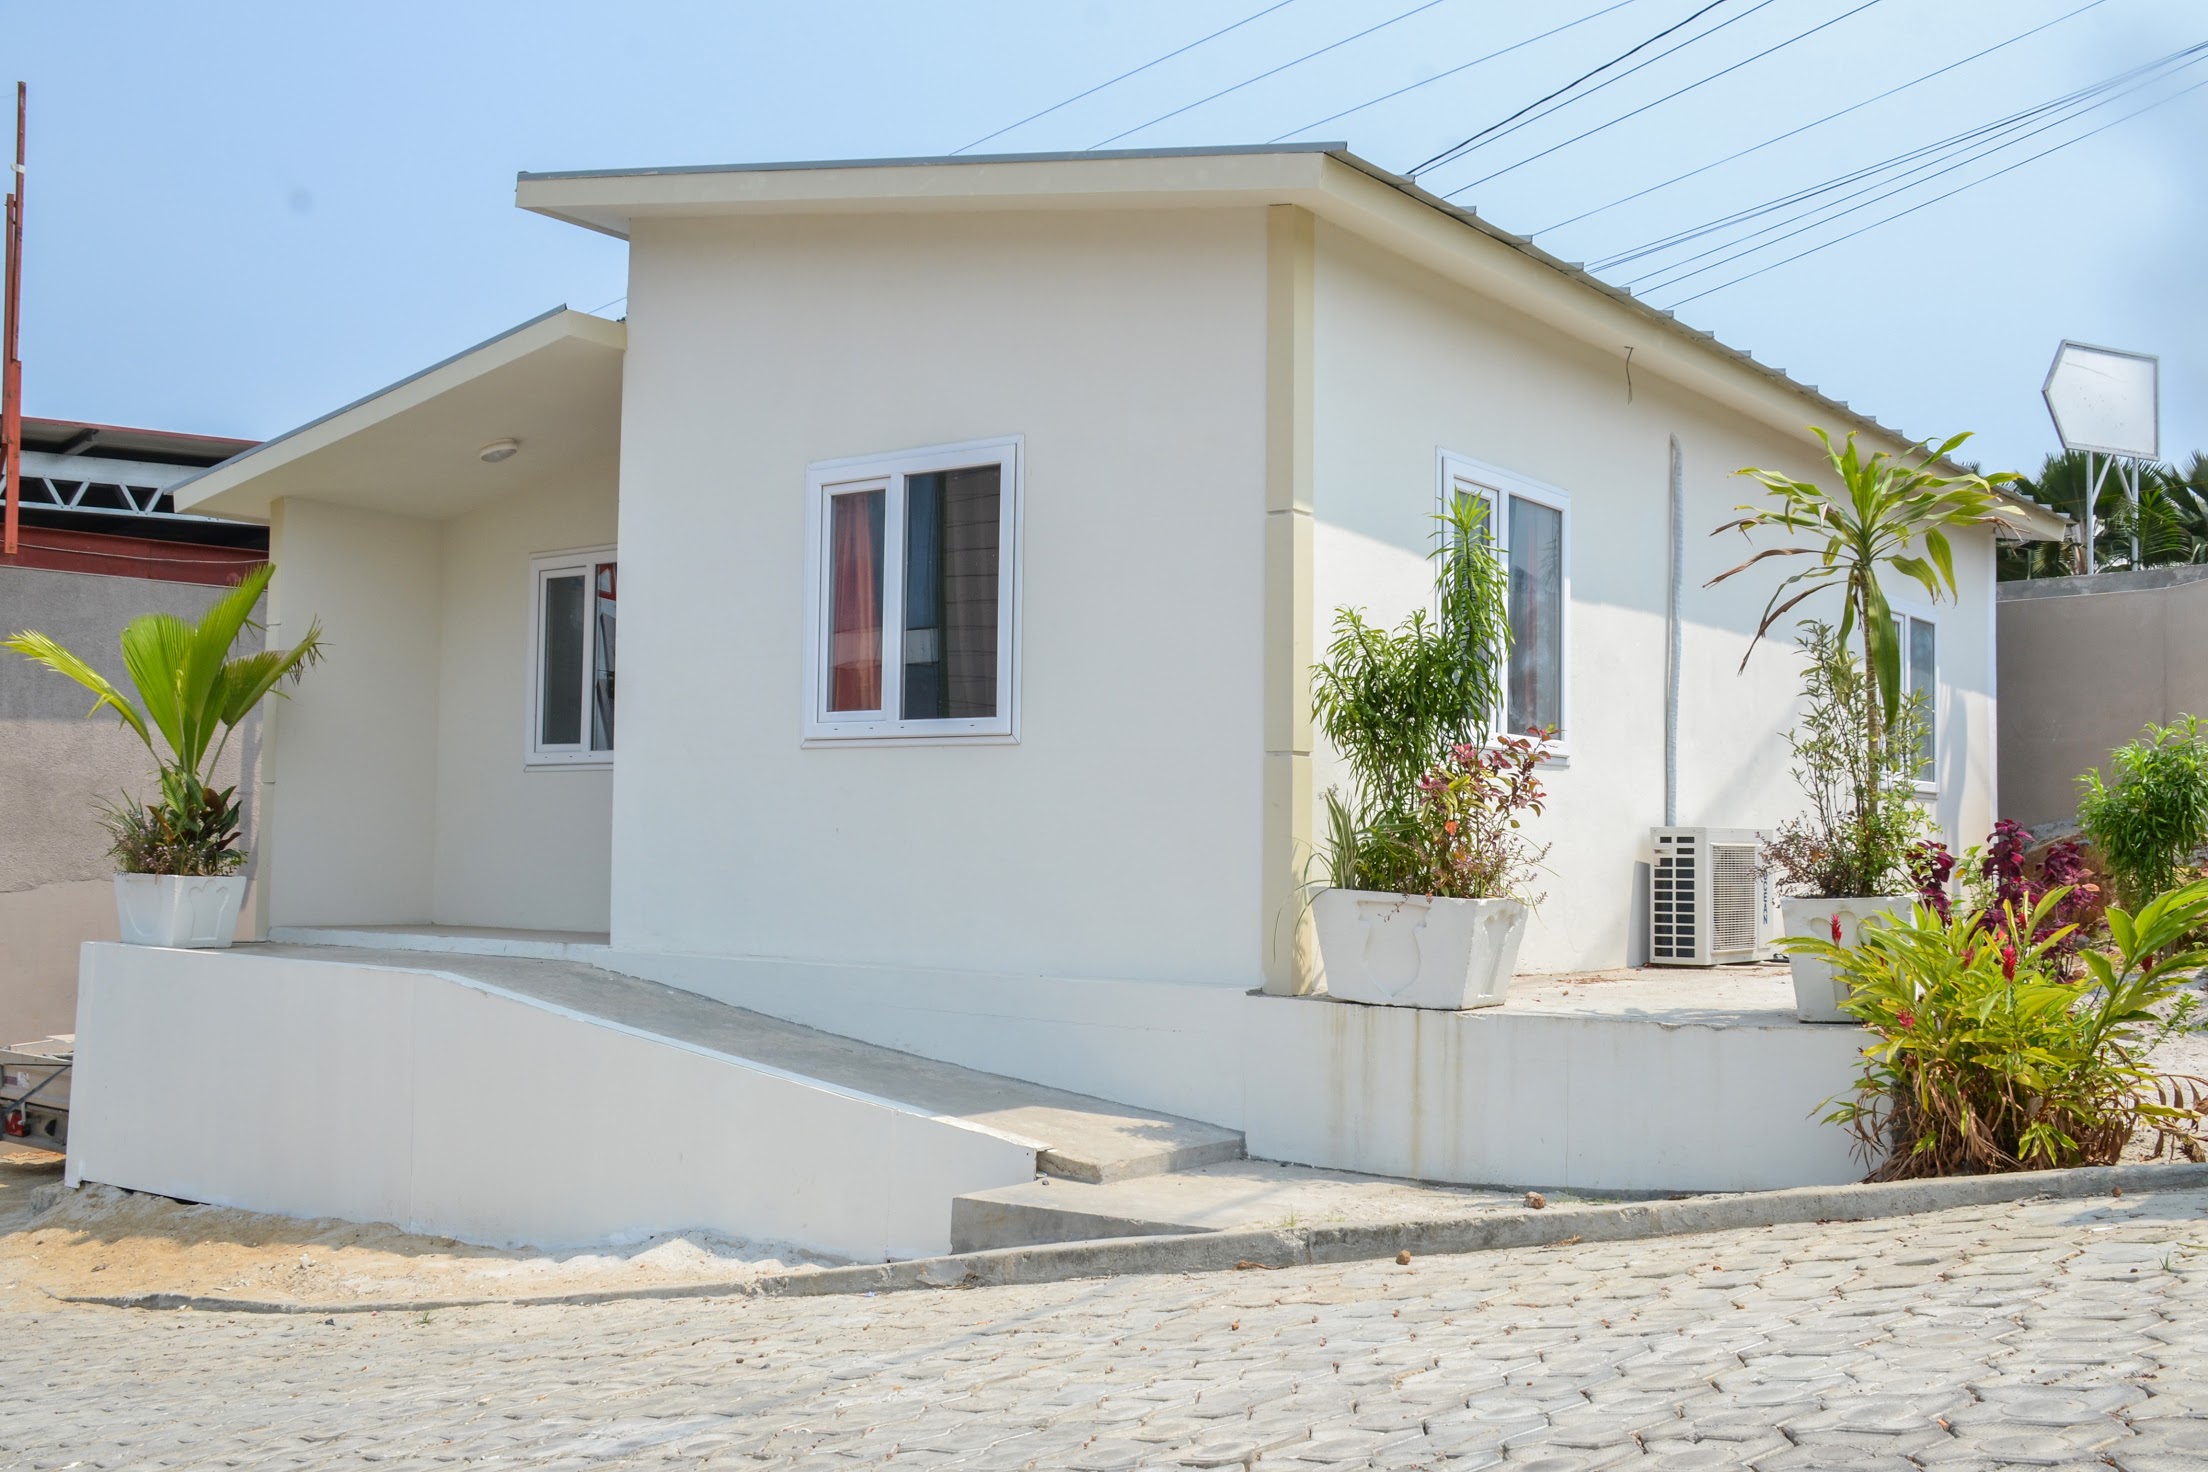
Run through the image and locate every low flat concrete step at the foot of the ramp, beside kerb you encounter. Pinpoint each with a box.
[952,1161,1565,1251]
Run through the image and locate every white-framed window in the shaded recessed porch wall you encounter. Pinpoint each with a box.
[526,547,620,766]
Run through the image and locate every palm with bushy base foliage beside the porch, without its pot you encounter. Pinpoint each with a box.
[0,565,322,874]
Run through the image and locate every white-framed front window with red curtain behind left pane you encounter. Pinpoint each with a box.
[804,439,1020,742]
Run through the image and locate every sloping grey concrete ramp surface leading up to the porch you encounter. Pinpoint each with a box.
[253,944,1243,1185]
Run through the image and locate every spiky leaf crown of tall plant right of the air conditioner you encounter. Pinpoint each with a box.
[1705,428,2016,755]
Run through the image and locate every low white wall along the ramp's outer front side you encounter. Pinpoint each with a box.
[68,942,1036,1260]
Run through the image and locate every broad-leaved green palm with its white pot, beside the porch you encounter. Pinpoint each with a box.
[0,565,322,949]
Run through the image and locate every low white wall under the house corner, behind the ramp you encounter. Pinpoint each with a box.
[598,951,1864,1192]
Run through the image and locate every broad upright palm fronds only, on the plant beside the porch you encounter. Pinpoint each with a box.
[0,565,322,807]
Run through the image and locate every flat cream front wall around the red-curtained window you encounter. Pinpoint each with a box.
[614,210,1265,986]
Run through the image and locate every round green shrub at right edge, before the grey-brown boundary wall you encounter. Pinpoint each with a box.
[2078,715,2208,905]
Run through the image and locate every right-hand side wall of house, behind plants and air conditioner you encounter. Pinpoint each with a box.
[1312,223,1994,971]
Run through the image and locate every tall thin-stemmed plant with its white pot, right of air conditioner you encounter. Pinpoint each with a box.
[1709,430,2016,1022]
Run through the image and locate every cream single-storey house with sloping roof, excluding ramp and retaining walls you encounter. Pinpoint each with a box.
[179,146,2049,989]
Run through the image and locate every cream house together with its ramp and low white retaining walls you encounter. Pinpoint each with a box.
[73,146,2058,1256]
